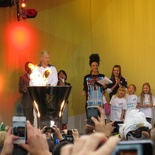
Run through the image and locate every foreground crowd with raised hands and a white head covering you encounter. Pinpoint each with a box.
[1,107,155,155]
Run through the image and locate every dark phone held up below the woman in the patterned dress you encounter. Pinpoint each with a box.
[87,106,100,125]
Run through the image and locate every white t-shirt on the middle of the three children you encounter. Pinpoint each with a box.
[125,94,138,109]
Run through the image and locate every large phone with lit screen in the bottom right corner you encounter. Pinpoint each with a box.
[112,140,153,155]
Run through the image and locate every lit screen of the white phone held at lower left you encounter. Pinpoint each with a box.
[13,121,25,137]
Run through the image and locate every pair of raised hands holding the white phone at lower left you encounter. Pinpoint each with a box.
[1,121,51,155]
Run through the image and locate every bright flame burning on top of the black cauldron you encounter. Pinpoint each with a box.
[29,63,52,86]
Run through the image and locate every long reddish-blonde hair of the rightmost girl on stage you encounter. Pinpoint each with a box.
[140,82,153,106]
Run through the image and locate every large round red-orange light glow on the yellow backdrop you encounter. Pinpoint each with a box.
[3,21,42,69]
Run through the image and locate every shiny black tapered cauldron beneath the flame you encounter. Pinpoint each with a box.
[27,85,71,127]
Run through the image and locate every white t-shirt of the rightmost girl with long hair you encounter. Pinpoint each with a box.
[138,94,155,118]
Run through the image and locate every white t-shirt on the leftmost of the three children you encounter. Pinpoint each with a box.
[110,95,127,121]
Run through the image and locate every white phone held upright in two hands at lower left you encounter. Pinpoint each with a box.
[12,116,26,144]
